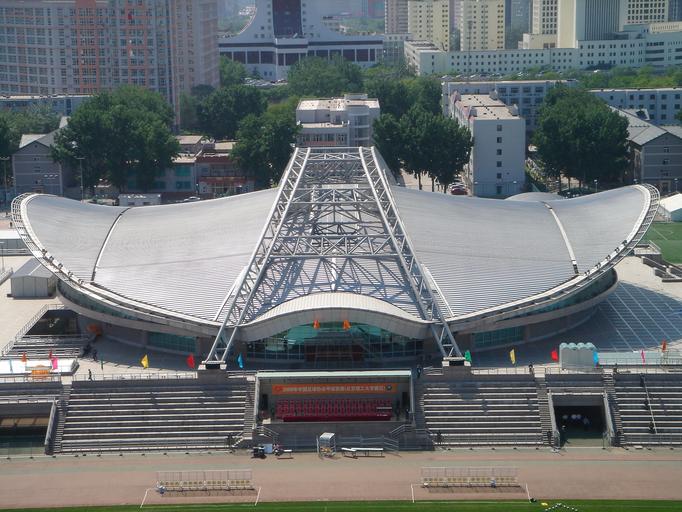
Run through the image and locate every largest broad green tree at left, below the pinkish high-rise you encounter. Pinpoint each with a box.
[53,86,179,190]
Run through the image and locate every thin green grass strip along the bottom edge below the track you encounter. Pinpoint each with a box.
[1,500,682,512]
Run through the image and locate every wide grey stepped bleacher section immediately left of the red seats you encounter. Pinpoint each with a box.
[61,379,249,452]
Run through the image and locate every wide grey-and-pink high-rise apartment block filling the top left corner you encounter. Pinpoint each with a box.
[0,0,219,120]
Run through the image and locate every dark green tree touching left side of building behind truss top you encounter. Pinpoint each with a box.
[232,98,298,188]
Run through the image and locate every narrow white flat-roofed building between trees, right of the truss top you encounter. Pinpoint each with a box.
[450,92,526,198]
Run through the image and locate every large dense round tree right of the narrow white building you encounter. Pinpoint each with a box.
[534,87,628,184]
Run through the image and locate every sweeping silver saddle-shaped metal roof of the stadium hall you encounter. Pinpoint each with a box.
[13,148,658,356]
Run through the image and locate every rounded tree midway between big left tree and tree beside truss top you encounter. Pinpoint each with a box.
[197,85,265,140]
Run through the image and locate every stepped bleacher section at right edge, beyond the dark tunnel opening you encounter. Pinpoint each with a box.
[615,372,682,445]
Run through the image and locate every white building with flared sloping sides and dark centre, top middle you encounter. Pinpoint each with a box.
[219,0,383,81]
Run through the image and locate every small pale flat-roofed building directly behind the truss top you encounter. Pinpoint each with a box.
[296,94,380,147]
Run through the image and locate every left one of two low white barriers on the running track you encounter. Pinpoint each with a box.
[156,469,254,492]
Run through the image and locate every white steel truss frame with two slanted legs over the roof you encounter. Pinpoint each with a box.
[206,148,462,363]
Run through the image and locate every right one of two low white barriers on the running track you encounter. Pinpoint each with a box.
[421,467,519,487]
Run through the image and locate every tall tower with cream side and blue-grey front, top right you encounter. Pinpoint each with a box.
[557,0,627,48]
